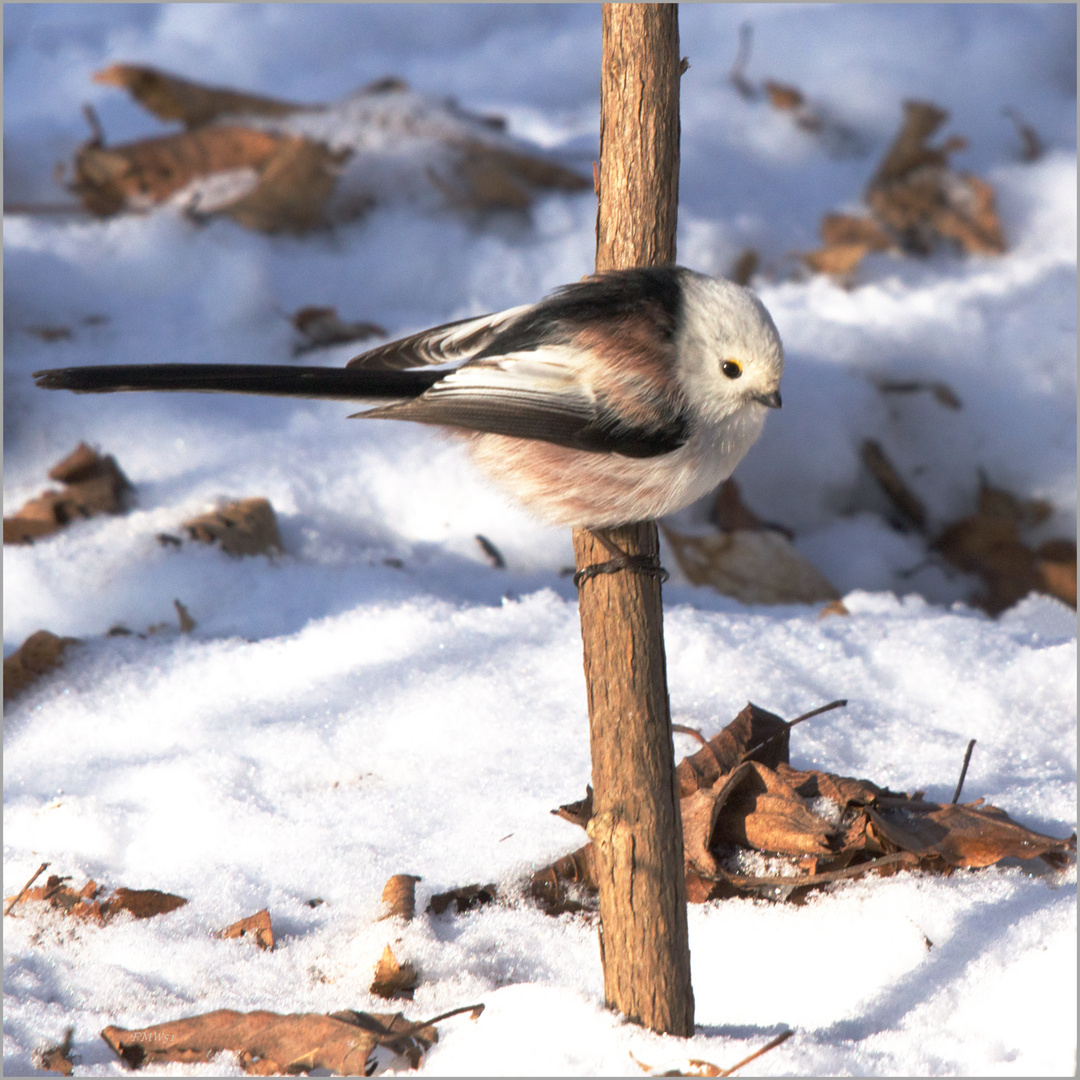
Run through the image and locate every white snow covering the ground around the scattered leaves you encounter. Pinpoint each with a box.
[3,4,1077,1076]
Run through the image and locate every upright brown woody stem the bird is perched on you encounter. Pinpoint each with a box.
[573,3,693,1036]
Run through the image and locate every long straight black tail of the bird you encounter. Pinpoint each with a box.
[33,364,446,401]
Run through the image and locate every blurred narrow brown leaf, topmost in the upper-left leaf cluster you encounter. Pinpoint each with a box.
[93,64,310,129]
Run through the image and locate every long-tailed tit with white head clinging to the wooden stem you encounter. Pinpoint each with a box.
[35,267,784,527]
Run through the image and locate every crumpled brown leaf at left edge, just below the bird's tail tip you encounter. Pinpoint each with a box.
[3,443,133,543]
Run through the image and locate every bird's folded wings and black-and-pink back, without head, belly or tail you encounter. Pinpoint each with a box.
[348,268,688,458]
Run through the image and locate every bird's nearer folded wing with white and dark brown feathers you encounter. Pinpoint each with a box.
[356,345,686,458]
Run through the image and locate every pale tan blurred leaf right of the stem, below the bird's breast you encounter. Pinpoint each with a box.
[661,525,840,604]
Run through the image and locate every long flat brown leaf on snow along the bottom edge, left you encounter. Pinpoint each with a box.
[102,1005,484,1076]
